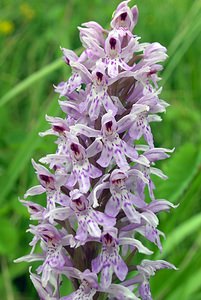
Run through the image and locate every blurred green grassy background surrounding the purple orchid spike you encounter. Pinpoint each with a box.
[0,0,201,300]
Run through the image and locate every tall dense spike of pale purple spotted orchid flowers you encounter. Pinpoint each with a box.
[16,0,175,300]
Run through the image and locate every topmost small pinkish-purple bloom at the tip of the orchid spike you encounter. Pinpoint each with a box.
[110,0,138,31]
